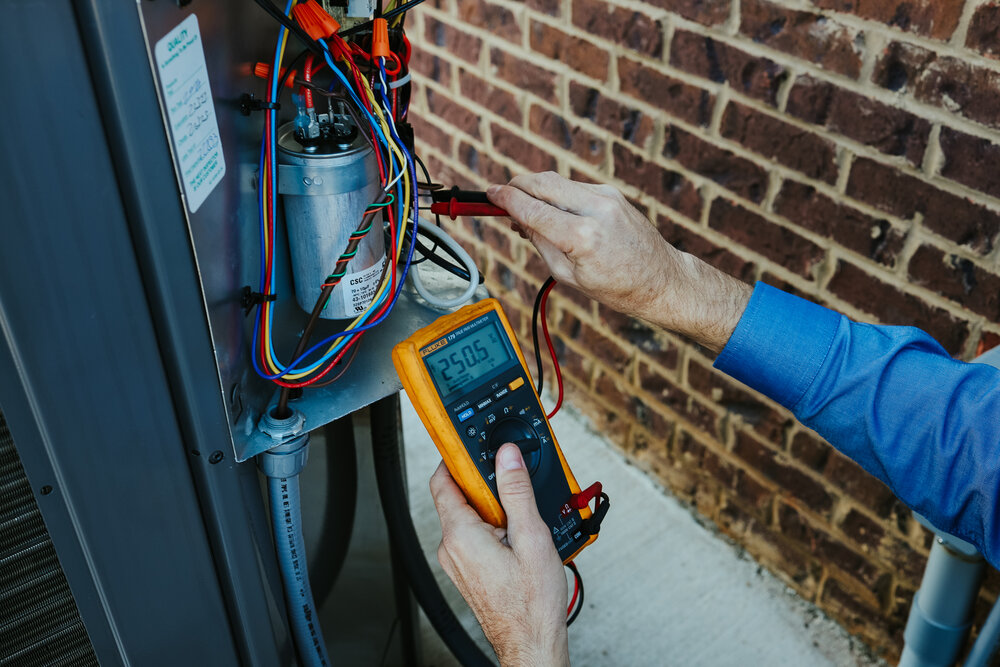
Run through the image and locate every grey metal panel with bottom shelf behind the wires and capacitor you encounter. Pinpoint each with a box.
[136,0,448,461]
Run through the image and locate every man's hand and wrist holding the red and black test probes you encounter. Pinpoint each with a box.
[487,172,751,352]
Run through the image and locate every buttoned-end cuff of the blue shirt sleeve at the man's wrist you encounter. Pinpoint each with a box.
[714,282,843,411]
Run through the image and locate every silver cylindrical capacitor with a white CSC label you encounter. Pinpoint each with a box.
[278,123,386,320]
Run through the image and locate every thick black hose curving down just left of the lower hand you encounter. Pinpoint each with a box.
[371,394,493,667]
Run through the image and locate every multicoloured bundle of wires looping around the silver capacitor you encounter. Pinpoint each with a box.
[252,0,417,402]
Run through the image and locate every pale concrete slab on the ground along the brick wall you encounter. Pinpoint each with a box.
[403,395,884,667]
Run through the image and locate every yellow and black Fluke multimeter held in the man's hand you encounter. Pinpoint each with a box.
[392,299,603,563]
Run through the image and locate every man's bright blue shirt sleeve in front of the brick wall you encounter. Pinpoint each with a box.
[715,283,1000,566]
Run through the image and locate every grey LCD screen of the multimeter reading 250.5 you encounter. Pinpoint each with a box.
[424,322,511,396]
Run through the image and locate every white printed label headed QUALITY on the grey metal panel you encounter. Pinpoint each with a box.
[153,14,226,213]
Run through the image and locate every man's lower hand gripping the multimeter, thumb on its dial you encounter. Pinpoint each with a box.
[431,444,569,666]
